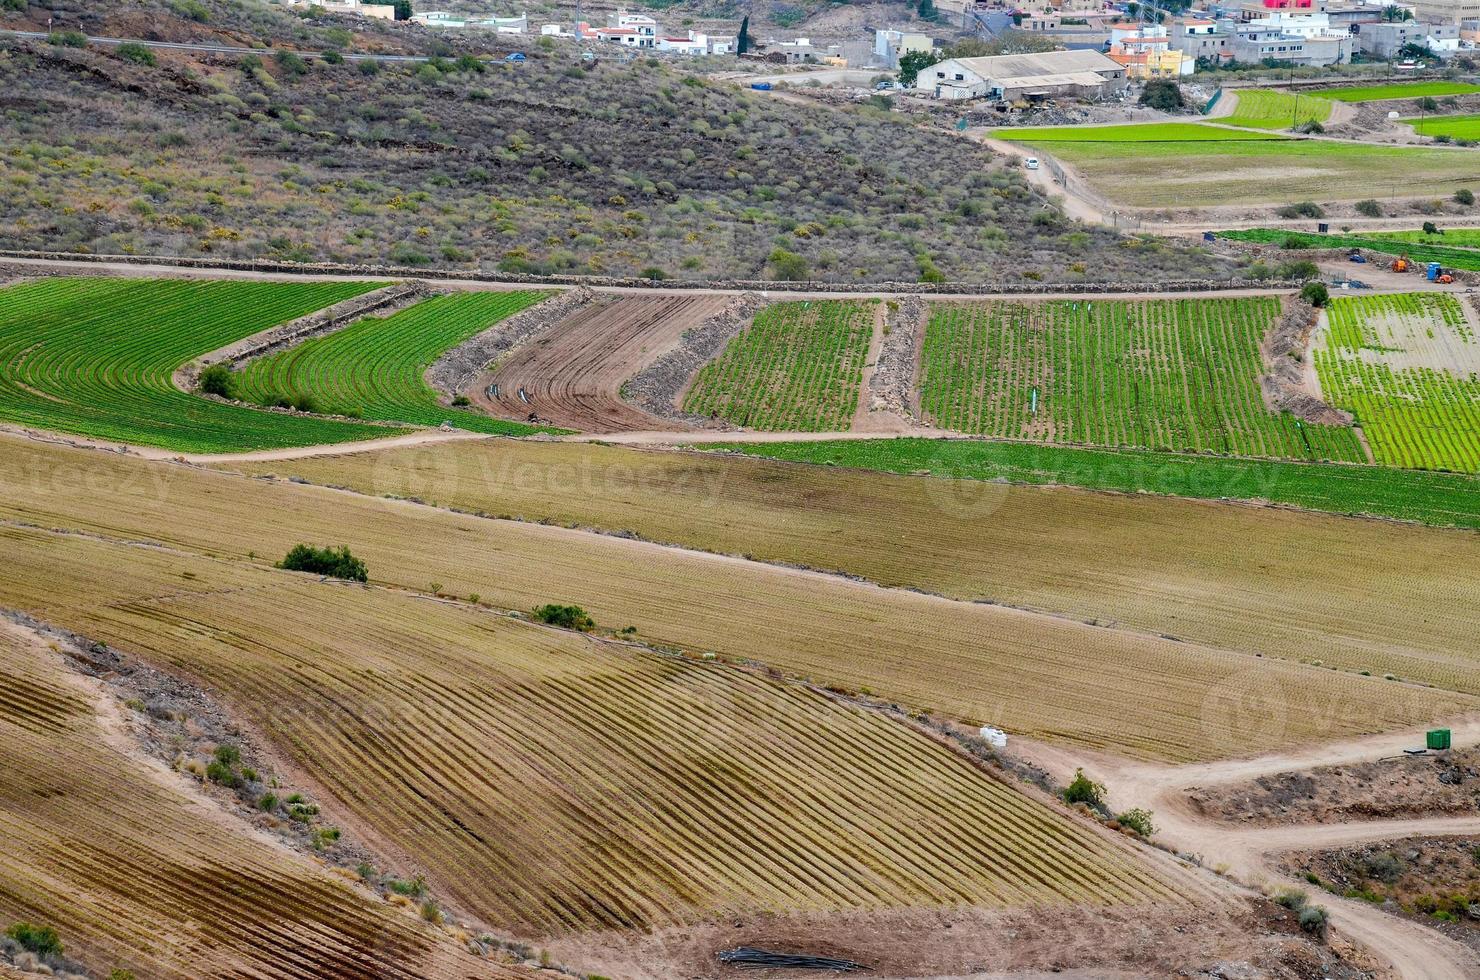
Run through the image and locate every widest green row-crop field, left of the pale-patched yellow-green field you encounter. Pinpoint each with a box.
[921,298,1365,462]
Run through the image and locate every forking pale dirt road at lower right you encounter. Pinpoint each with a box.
[1011,718,1480,980]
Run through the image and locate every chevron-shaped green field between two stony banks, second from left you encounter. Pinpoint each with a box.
[237,290,549,435]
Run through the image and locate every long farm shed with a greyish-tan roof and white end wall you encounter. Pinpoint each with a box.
[915,50,1126,102]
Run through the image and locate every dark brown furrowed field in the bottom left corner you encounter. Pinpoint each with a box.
[0,621,503,980]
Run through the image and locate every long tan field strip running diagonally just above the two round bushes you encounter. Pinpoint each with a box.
[0,440,1477,761]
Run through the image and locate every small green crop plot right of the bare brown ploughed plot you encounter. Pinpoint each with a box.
[684,301,878,432]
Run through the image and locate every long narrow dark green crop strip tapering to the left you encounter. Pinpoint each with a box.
[694,437,1480,530]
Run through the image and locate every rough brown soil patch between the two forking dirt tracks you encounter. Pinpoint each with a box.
[1187,746,1480,825]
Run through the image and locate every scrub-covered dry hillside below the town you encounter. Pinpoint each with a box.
[0,0,1224,281]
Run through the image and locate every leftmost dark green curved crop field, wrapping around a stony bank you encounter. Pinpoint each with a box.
[0,278,388,453]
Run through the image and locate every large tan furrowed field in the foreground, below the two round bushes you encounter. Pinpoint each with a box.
[0,527,1180,934]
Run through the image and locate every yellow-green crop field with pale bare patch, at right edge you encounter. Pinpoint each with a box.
[1316,293,1480,474]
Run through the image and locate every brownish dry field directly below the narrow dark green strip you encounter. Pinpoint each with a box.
[219,441,1480,706]
